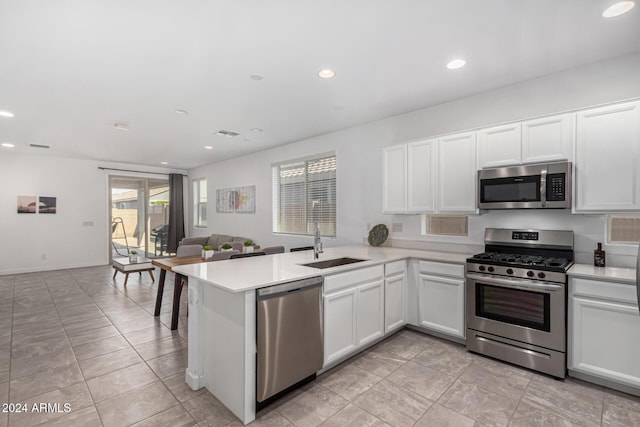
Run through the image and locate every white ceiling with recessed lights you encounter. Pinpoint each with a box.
[0,0,640,169]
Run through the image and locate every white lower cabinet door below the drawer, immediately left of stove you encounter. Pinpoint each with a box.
[418,274,465,338]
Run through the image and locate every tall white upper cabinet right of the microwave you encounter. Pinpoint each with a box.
[575,102,640,212]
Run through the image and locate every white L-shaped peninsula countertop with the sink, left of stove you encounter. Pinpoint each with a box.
[173,246,472,292]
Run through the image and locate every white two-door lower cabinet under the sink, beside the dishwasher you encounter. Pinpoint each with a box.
[323,265,384,366]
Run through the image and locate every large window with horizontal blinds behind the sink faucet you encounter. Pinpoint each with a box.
[273,154,336,237]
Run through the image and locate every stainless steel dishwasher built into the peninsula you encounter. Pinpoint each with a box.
[256,277,323,404]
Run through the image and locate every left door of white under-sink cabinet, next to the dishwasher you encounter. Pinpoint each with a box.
[324,288,357,365]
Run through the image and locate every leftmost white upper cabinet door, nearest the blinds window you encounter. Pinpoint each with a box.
[382,144,407,213]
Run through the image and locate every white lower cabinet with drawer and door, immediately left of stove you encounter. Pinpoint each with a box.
[417,261,466,338]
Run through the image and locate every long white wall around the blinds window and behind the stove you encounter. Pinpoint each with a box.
[188,54,640,265]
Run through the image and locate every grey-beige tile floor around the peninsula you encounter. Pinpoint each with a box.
[0,266,640,427]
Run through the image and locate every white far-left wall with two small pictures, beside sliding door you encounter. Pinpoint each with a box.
[0,151,185,275]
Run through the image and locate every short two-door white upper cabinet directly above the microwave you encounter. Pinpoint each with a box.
[478,113,575,168]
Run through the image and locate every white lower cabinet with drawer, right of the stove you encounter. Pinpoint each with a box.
[568,278,640,389]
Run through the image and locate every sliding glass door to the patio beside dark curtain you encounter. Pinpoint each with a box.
[109,176,172,258]
